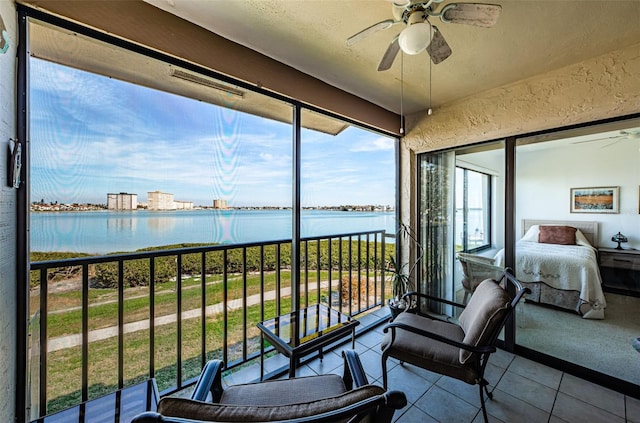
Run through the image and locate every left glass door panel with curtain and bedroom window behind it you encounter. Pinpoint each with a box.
[418,142,505,312]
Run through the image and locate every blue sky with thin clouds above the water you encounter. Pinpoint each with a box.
[30,59,395,210]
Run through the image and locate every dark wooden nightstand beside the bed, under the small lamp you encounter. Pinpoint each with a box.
[598,248,640,297]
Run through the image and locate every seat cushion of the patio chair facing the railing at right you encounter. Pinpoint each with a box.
[380,313,478,384]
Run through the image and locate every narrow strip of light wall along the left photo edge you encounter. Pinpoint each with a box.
[0,0,17,422]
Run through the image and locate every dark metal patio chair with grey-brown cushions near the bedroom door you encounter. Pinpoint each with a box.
[381,269,529,422]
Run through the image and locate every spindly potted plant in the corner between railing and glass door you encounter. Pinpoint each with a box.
[387,222,424,318]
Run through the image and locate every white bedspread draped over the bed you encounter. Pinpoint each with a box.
[496,240,606,319]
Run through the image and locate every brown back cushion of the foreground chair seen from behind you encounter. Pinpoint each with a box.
[158,386,384,422]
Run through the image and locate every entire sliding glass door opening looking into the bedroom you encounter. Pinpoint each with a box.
[418,118,640,386]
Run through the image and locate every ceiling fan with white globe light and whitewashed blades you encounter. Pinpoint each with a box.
[347,0,502,71]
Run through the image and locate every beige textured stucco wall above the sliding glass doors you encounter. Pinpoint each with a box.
[400,44,640,227]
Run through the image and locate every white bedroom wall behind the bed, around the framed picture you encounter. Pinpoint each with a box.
[516,140,640,249]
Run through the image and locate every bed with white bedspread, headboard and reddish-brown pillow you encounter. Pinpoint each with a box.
[495,219,606,319]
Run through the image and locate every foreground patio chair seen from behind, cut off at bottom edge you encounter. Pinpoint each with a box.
[132,350,407,423]
